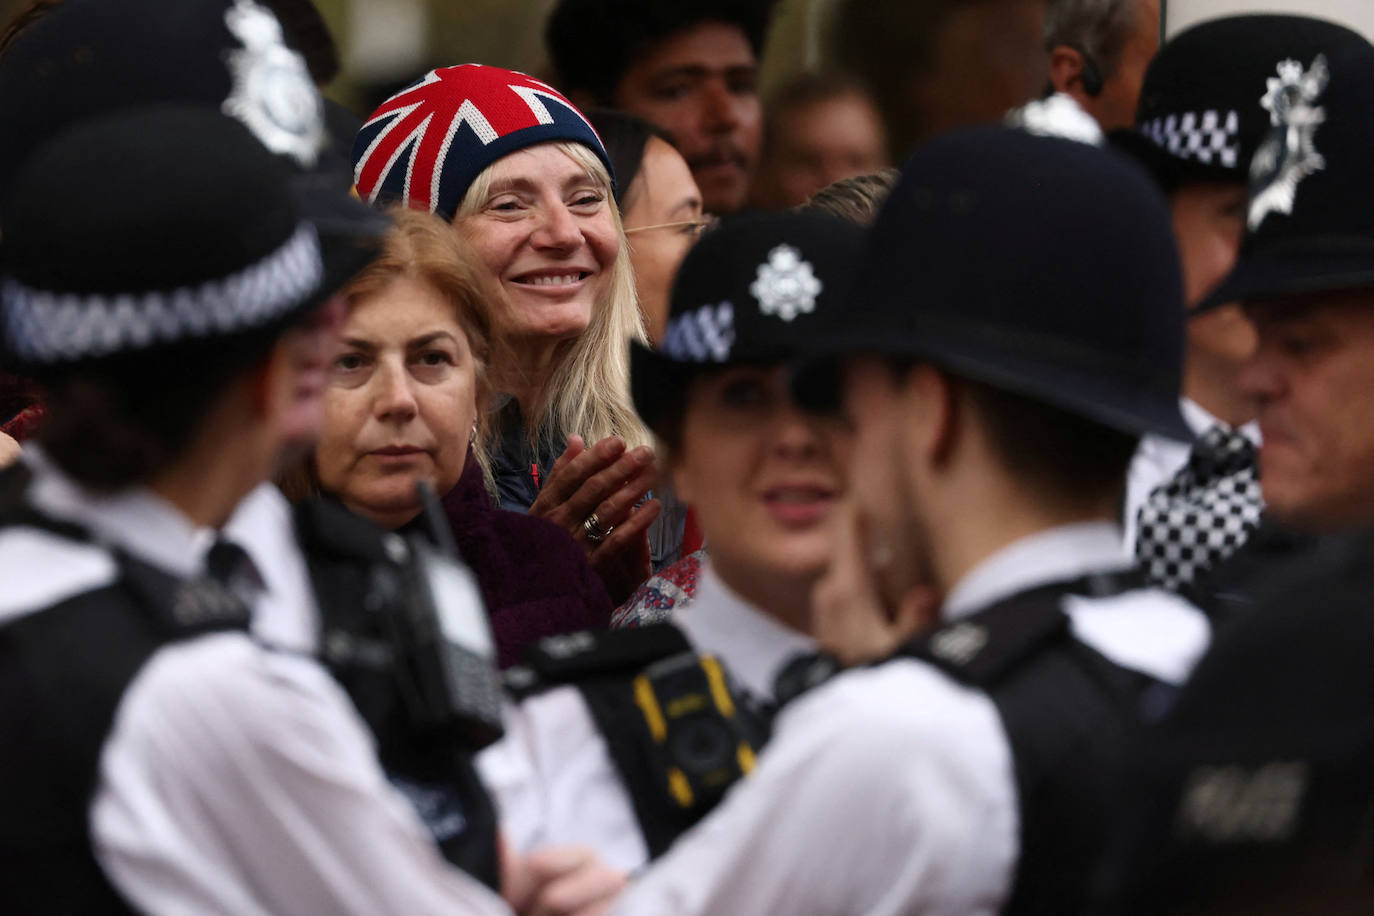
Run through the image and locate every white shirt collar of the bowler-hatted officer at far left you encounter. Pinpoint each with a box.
[23,444,214,577]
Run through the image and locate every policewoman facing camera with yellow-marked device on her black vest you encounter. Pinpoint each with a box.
[480,213,861,871]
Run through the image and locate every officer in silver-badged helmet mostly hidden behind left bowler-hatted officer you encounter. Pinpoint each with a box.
[0,0,524,886]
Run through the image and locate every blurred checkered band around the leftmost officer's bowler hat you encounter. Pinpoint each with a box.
[0,222,324,364]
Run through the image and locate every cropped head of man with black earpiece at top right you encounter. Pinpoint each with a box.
[1044,0,1160,130]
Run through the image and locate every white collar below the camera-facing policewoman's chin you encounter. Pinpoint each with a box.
[673,562,816,699]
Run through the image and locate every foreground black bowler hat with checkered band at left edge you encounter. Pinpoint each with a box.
[0,106,375,375]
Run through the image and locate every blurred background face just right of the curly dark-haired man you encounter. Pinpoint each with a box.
[750,73,888,210]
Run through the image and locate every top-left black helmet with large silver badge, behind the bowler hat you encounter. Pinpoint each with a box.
[0,0,387,244]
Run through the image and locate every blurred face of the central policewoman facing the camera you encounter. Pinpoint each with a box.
[672,367,848,601]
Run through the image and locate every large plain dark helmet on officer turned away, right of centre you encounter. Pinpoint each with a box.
[796,126,1191,439]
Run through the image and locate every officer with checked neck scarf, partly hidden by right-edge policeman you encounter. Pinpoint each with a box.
[1112,15,1369,593]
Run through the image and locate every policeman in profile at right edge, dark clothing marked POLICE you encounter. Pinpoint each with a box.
[1121,39,1374,913]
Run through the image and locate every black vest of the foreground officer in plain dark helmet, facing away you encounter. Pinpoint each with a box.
[899,571,1151,913]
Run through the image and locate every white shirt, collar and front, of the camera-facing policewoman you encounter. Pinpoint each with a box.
[477,564,815,871]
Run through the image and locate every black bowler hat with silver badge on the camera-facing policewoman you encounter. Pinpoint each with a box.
[629,211,863,433]
